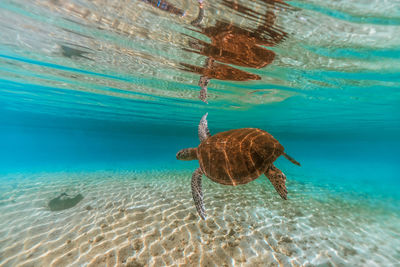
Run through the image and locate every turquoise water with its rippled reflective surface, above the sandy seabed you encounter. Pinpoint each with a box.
[0,0,400,266]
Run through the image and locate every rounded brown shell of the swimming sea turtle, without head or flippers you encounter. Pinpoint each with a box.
[197,128,284,185]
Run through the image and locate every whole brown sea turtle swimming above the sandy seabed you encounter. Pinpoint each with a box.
[176,113,300,220]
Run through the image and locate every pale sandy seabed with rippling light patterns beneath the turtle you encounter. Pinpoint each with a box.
[0,170,400,266]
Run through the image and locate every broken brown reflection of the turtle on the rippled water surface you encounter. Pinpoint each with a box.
[181,0,286,103]
